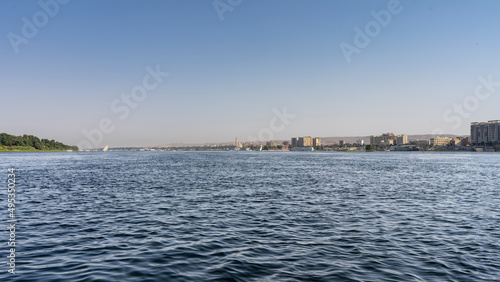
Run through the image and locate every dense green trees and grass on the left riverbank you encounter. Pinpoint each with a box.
[0,133,78,152]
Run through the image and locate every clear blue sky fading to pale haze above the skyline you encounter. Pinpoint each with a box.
[0,0,500,147]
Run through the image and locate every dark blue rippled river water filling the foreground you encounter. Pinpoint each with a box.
[0,152,500,281]
